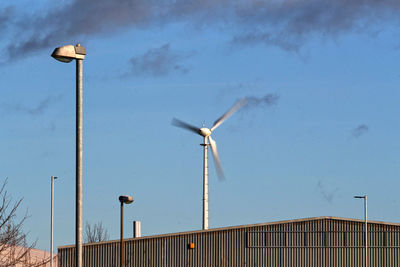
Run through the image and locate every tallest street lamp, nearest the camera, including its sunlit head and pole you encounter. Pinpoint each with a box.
[51,44,86,267]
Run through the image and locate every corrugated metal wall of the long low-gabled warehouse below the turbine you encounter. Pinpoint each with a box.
[58,219,400,267]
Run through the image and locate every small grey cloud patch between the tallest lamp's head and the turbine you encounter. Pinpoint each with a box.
[129,44,190,76]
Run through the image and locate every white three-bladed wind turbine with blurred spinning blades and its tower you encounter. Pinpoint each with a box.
[172,98,247,230]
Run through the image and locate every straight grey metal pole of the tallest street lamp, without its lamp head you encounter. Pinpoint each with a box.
[75,59,83,267]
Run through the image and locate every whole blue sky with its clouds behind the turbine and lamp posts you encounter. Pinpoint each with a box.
[0,0,400,250]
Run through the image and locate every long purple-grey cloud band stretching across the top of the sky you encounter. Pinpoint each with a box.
[4,0,400,59]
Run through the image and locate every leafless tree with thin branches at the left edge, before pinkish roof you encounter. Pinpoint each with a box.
[0,179,48,267]
